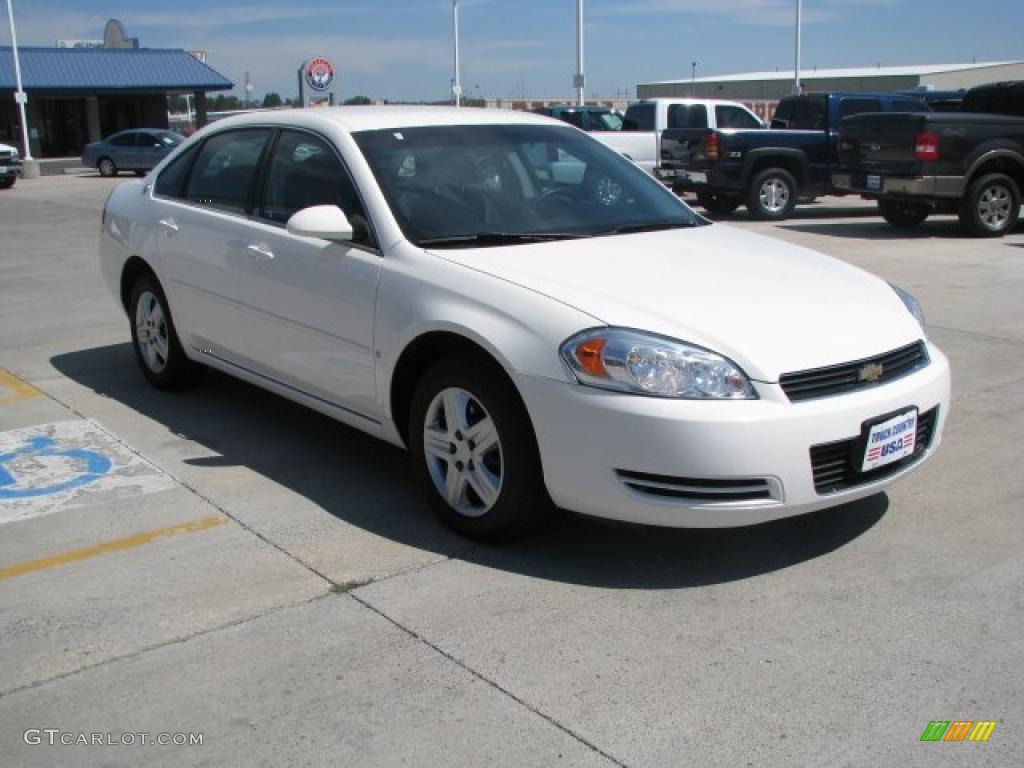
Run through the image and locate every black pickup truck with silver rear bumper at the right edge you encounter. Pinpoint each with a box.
[833,81,1024,238]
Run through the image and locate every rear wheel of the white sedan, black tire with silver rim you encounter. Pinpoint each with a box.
[128,272,201,389]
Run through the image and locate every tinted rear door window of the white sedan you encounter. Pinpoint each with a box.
[185,128,270,213]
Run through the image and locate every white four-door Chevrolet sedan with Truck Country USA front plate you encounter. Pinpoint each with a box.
[100,106,949,540]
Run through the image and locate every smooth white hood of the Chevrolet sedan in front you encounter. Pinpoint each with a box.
[433,224,923,382]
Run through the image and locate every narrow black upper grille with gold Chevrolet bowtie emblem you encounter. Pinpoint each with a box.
[779,341,928,402]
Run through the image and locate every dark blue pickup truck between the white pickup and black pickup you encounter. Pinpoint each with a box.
[662,93,929,219]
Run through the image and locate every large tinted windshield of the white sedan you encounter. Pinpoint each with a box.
[353,125,702,247]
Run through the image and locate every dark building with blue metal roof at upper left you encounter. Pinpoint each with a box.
[0,20,233,158]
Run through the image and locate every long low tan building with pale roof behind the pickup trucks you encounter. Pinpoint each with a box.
[637,61,1024,118]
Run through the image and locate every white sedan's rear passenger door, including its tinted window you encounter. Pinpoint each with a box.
[154,128,271,365]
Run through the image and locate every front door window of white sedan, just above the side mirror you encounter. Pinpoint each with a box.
[259,130,368,230]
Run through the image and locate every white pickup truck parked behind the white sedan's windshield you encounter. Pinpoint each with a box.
[591,98,764,177]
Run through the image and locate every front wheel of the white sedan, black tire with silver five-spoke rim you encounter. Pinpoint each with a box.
[409,354,551,542]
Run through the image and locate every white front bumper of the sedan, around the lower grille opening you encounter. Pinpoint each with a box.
[516,345,949,527]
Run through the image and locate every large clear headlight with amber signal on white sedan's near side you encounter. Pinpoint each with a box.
[559,328,757,400]
